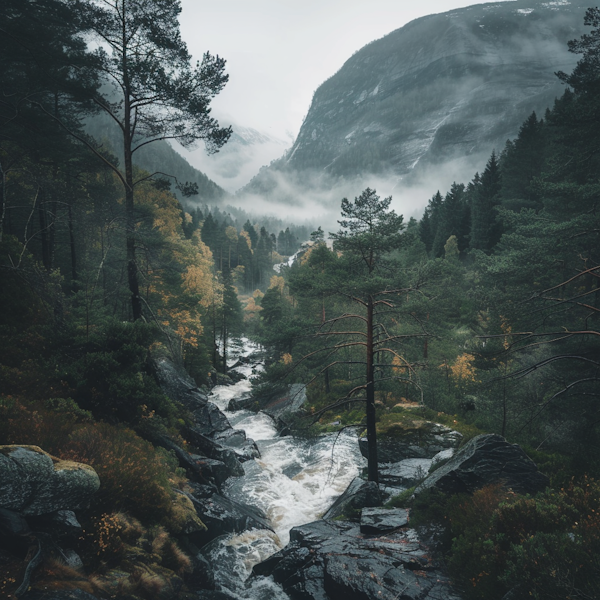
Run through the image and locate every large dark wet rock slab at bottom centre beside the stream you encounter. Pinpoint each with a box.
[253,521,459,600]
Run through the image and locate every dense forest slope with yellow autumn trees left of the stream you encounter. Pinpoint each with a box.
[0,0,305,598]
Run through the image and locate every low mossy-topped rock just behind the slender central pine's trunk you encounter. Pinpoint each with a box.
[358,419,463,463]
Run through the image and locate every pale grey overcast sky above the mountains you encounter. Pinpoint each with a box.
[181,0,516,139]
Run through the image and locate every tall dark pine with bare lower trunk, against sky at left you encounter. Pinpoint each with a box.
[78,0,231,320]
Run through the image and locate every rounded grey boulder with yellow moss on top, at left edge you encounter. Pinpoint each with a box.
[0,446,100,515]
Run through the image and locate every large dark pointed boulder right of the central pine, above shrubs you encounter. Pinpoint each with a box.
[415,434,549,495]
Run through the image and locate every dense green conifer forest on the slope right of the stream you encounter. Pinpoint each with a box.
[253,9,600,599]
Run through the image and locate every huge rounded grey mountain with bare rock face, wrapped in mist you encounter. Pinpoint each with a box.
[244,0,589,213]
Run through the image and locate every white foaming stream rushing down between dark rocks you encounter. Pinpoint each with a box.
[202,339,366,600]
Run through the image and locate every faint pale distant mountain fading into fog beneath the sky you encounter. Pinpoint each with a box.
[177,119,292,193]
